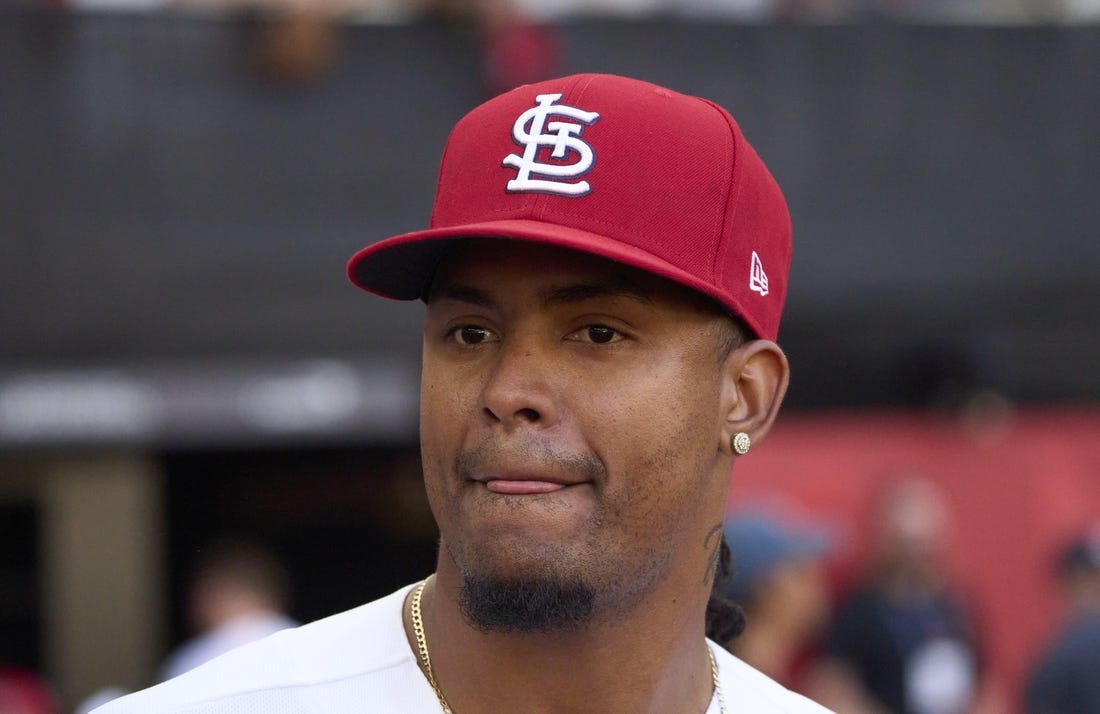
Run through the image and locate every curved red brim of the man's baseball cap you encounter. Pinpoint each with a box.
[348,219,758,330]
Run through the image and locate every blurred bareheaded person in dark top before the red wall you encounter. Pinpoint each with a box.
[811,476,979,714]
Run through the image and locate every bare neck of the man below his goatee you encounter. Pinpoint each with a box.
[405,573,713,714]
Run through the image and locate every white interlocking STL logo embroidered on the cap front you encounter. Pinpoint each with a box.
[503,94,600,196]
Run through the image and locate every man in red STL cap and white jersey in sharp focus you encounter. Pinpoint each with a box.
[94,75,824,714]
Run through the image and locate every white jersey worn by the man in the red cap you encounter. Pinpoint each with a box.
[94,585,826,714]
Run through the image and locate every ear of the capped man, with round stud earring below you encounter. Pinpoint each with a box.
[721,340,790,457]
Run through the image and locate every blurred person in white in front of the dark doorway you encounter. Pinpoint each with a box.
[158,539,298,681]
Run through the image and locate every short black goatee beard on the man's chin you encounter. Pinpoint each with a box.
[459,574,596,633]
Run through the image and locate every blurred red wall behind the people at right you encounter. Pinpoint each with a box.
[729,408,1100,710]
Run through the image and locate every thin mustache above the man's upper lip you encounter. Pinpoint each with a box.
[454,441,607,483]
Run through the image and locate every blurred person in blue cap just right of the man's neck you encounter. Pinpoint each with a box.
[725,510,829,691]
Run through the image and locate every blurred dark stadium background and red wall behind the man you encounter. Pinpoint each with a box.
[0,0,1100,714]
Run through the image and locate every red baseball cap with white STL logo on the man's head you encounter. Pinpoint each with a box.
[348,74,791,340]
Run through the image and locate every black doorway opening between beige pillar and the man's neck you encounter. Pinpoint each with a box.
[165,447,438,642]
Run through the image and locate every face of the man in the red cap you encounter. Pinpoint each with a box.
[420,240,728,629]
